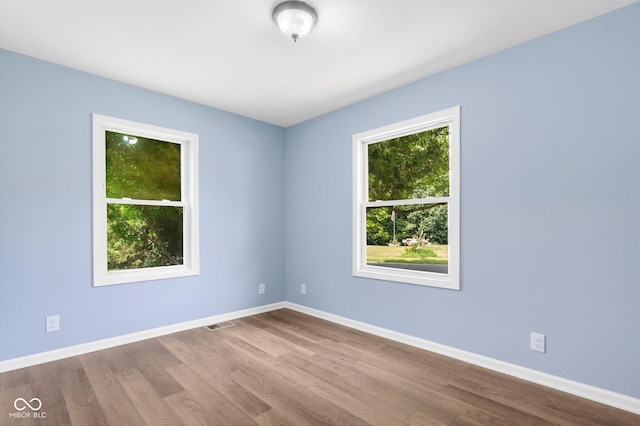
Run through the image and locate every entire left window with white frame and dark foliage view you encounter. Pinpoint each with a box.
[93,114,199,286]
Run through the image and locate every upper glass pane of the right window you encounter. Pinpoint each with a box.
[367,127,449,201]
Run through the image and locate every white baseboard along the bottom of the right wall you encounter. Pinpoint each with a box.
[284,302,640,414]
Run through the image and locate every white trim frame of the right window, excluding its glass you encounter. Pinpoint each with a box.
[353,106,460,290]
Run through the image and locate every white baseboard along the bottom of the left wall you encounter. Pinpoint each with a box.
[0,302,284,373]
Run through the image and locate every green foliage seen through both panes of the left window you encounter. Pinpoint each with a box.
[106,132,183,270]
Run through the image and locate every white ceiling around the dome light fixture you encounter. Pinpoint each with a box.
[0,0,637,126]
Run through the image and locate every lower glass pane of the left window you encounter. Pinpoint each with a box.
[107,204,183,271]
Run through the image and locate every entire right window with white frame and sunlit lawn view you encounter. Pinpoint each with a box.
[353,107,460,290]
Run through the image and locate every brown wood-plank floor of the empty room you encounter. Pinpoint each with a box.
[0,309,640,426]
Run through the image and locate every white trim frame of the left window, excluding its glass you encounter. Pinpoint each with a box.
[93,114,200,287]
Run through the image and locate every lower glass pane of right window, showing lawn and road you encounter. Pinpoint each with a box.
[367,203,449,274]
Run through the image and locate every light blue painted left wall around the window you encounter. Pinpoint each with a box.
[0,50,285,361]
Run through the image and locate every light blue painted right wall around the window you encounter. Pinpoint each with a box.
[285,3,640,397]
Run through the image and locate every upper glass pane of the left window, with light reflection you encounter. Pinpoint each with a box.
[106,131,181,201]
